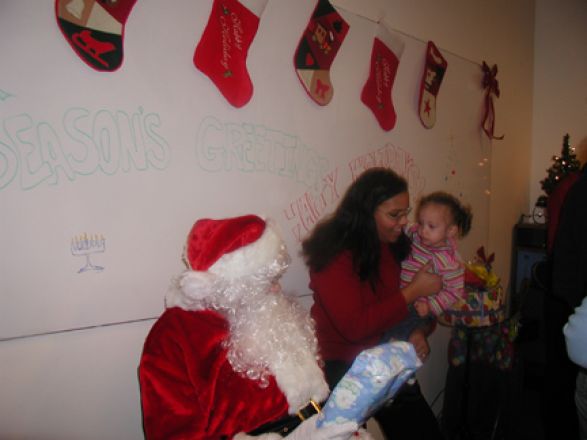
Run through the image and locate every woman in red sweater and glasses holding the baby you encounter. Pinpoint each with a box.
[302,168,442,440]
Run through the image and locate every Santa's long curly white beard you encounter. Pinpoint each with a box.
[226,286,329,414]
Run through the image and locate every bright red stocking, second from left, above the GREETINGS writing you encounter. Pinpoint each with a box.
[194,0,268,107]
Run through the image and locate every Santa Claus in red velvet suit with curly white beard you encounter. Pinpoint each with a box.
[139,215,366,440]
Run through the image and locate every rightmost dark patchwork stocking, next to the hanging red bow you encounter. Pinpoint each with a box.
[418,41,448,128]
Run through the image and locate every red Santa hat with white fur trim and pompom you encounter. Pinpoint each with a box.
[166,215,286,309]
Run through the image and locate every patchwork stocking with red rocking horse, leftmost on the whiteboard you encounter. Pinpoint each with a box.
[55,0,137,72]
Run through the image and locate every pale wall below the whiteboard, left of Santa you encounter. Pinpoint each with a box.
[0,321,152,440]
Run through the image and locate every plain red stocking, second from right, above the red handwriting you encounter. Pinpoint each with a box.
[361,24,404,131]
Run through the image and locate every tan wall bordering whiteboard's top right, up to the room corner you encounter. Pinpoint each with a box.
[382,0,534,306]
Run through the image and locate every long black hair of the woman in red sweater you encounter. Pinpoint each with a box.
[302,168,410,285]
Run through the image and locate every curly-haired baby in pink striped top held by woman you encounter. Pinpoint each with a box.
[384,191,473,341]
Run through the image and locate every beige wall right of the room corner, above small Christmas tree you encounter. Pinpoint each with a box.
[528,0,587,210]
